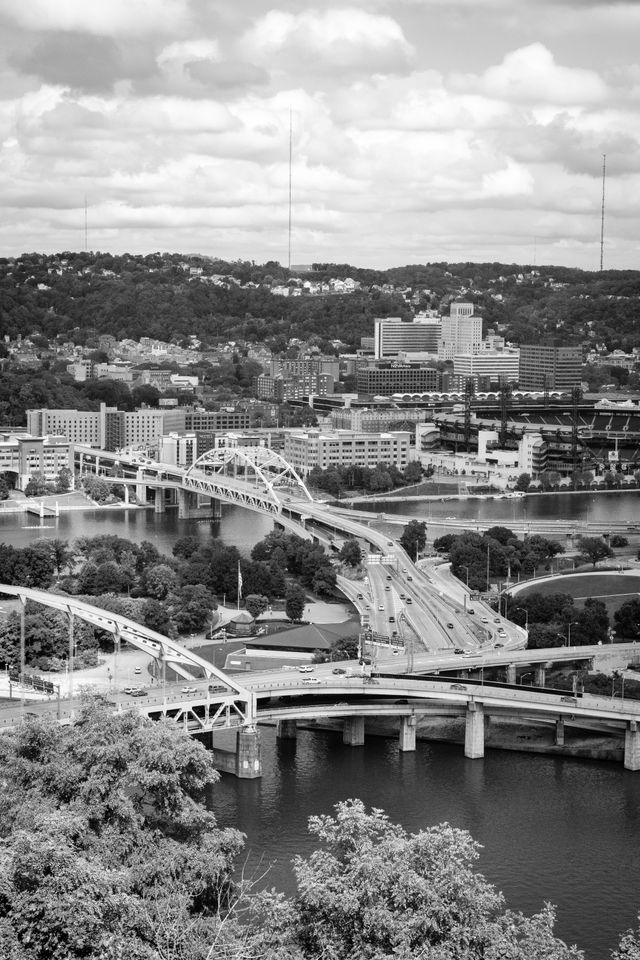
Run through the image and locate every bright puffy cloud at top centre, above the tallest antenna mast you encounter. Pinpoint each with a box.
[239,8,413,72]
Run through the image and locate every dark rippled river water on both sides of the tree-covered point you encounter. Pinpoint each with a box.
[0,493,640,960]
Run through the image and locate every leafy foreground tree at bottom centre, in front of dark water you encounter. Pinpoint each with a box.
[252,800,580,960]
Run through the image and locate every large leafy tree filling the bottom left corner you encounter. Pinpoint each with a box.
[0,701,242,960]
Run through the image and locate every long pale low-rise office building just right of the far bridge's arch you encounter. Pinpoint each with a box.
[284,430,411,475]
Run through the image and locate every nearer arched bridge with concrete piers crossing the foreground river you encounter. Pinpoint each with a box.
[0,584,640,778]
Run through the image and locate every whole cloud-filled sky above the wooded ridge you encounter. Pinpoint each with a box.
[0,0,640,269]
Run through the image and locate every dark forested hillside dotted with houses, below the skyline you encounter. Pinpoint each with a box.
[0,253,640,350]
